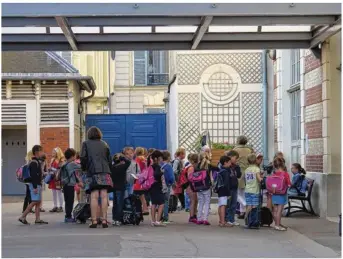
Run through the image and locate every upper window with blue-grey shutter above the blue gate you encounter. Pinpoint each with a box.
[134,50,169,86]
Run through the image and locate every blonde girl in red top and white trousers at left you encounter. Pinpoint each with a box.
[49,147,65,212]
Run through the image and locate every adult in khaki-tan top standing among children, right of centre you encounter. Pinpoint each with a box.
[233,136,254,219]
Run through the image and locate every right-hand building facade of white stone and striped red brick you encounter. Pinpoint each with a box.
[269,33,342,217]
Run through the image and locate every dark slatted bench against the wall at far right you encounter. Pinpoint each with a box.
[284,178,317,217]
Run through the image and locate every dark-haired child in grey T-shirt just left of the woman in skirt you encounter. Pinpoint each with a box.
[61,148,81,223]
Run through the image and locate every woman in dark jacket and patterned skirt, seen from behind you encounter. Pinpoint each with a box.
[80,127,113,228]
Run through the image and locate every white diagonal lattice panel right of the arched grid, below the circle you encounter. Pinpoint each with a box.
[242,93,263,152]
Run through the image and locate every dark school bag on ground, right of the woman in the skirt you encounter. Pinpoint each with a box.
[122,194,144,226]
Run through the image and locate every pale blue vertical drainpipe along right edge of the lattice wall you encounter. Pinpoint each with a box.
[262,50,269,165]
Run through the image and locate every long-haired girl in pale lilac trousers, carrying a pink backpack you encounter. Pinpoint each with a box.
[197,152,212,225]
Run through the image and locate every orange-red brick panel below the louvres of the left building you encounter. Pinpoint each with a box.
[40,127,69,161]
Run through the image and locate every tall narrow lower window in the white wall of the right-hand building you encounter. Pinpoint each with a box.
[290,90,301,163]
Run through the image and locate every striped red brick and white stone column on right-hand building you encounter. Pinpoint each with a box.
[304,51,324,172]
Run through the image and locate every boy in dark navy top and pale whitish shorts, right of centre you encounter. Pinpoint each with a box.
[218,156,232,227]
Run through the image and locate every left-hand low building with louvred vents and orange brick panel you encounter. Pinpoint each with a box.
[1,52,96,195]
